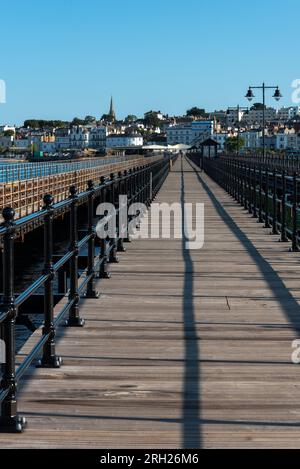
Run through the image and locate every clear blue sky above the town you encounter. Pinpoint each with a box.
[0,0,300,123]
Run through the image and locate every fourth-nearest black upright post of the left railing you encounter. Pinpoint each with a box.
[84,180,99,298]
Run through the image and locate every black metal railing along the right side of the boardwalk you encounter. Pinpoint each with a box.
[191,157,300,252]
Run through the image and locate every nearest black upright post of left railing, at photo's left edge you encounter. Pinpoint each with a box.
[0,207,26,433]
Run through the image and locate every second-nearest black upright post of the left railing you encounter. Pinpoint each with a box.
[38,194,62,368]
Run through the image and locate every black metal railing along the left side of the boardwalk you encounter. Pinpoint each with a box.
[0,158,176,432]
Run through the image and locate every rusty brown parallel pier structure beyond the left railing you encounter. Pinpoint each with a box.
[0,155,157,227]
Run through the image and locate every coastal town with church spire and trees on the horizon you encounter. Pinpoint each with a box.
[0,98,300,159]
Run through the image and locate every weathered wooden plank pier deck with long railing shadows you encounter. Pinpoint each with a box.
[0,155,300,448]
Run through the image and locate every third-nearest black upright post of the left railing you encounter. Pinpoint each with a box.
[66,186,85,327]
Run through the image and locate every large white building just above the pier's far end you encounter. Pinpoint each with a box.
[167,120,214,145]
